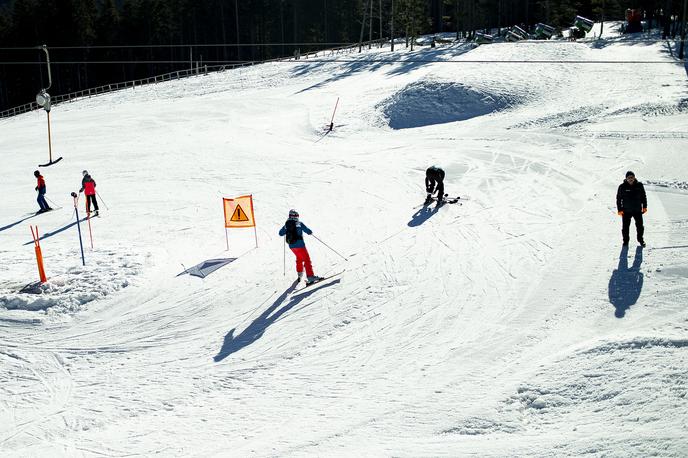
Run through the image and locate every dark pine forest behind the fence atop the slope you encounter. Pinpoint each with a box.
[0,0,682,110]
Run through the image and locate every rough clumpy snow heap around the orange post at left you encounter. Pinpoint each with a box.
[0,251,143,314]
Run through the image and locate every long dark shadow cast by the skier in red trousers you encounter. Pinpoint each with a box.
[213,279,341,363]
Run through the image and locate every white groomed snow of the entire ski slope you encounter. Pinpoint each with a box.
[0,27,688,457]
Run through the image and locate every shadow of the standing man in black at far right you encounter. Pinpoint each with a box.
[609,246,643,318]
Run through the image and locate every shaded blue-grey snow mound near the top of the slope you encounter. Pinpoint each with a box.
[378,81,519,129]
